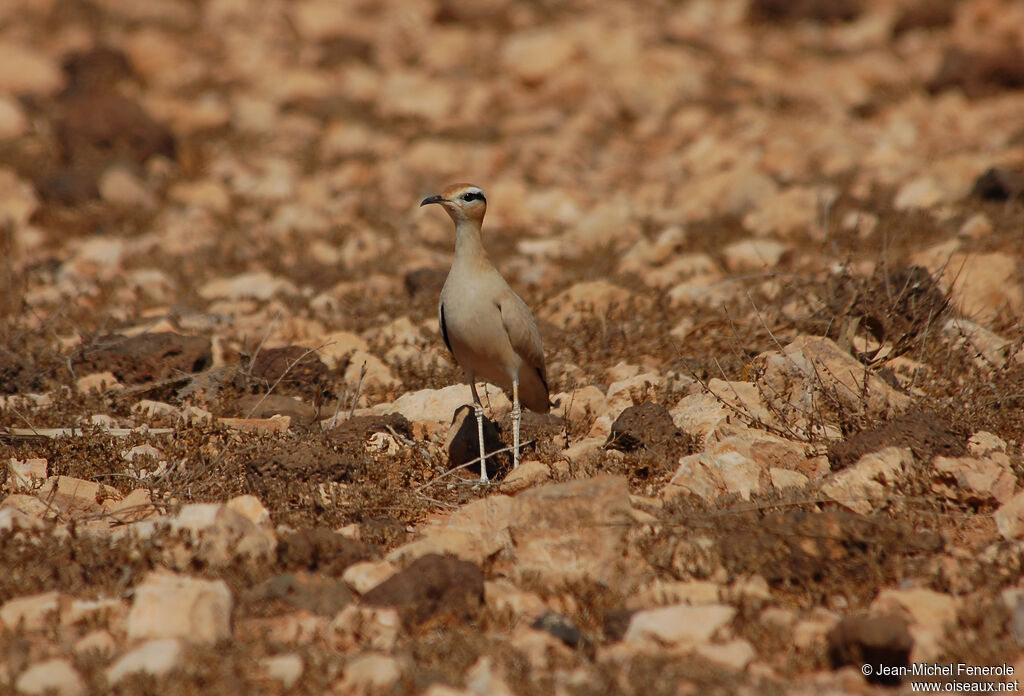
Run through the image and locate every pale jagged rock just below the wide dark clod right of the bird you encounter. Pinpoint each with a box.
[821,447,913,515]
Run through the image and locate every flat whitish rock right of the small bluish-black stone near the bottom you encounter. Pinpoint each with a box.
[623,604,736,647]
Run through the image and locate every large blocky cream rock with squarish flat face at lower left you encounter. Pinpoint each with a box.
[127,571,232,642]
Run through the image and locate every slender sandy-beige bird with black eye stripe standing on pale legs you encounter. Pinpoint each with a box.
[420,183,551,482]
